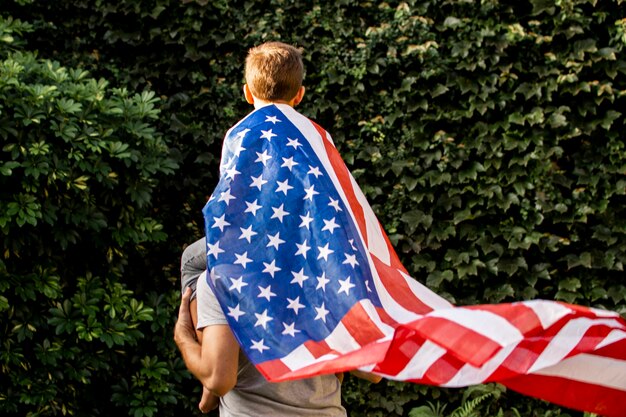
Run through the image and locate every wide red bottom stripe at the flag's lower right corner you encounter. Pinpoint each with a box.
[500,374,626,417]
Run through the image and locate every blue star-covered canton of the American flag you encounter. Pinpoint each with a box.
[203,105,380,363]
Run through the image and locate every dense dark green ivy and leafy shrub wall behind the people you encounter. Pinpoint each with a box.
[0,0,626,417]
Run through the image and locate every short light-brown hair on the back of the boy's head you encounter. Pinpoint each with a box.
[245,42,304,101]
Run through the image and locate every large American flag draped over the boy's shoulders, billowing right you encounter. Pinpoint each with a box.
[203,105,626,416]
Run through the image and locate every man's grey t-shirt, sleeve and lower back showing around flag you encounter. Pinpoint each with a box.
[196,274,346,417]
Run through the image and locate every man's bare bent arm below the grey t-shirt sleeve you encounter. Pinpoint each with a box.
[174,289,239,397]
